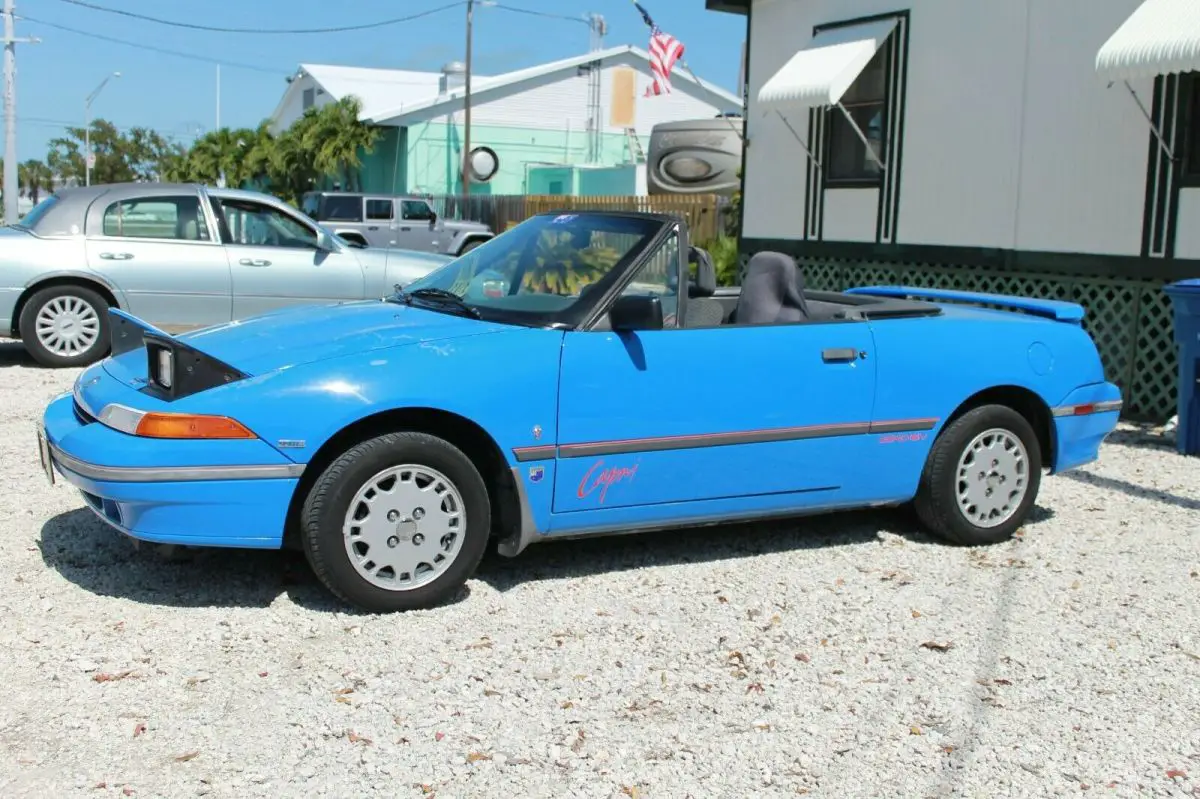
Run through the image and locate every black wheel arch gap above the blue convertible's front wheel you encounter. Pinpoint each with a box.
[283,407,521,548]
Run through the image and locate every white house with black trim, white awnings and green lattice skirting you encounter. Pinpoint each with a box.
[707,0,1200,416]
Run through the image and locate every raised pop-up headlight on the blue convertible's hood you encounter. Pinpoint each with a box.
[108,308,250,402]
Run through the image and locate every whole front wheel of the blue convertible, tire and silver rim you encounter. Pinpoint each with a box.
[301,433,491,613]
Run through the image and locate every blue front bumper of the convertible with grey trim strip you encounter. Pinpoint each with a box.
[40,386,304,549]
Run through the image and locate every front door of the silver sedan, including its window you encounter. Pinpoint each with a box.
[212,196,365,319]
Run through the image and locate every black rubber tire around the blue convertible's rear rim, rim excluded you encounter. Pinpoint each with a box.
[917,405,1042,546]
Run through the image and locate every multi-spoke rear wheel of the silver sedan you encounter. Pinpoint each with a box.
[18,286,109,367]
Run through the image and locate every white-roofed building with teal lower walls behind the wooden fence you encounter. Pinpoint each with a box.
[271,46,742,194]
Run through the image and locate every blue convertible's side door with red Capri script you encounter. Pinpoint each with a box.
[553,226,875,520]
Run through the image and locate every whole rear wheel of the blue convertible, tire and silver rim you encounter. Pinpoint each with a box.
[913,405,1042,546]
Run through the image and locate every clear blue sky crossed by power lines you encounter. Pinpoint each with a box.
[9,0,744,161]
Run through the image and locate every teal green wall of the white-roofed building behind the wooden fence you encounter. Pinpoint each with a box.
[396,121,644,194]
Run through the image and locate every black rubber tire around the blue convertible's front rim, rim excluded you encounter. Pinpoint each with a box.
[301,433,491,613]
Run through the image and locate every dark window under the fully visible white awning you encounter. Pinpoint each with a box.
[824,42,892,186]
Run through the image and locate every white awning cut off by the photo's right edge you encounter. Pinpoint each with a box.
[1096,0,1200,82]
